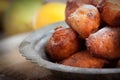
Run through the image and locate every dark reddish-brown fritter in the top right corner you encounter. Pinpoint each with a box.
[101,0,120,27]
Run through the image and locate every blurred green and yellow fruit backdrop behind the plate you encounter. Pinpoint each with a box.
[0,0,66,39]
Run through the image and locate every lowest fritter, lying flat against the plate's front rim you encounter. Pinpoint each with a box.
[62,51,108,68]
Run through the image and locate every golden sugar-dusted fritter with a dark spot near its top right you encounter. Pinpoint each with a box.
[66,4,100,38]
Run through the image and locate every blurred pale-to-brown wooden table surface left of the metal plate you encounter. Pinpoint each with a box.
[0,34,52,80]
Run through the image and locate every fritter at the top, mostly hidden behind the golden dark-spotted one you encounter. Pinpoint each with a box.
[65,0,104,19]
